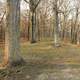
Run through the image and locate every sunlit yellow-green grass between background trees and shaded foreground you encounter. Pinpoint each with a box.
[21,41,80,64]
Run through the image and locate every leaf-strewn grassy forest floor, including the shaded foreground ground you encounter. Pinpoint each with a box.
[0,41,80,80]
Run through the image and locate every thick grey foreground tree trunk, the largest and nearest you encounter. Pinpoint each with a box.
[5,0,23,66]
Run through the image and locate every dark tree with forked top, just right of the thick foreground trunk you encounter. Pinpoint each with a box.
[24,0,41,43]
